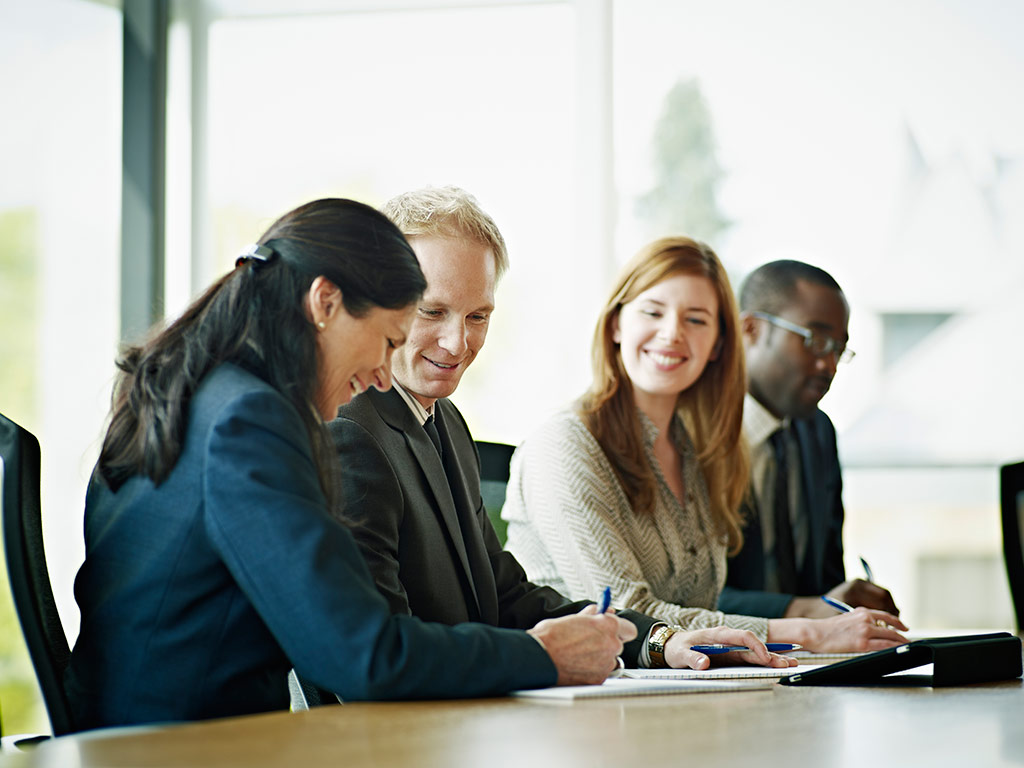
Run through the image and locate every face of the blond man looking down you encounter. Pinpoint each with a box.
[393,234,496,408]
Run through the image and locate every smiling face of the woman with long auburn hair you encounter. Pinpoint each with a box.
[612,274,719,421]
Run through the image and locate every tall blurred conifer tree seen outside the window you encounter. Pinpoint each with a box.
[637,80,729,245]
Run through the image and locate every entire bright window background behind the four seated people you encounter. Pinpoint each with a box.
[0,0,1024,732]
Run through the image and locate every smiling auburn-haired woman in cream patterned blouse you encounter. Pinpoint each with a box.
[502,237,904,651]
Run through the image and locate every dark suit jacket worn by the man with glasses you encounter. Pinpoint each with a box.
[718,411,846,617]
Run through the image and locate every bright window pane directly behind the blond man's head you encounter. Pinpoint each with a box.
[168,3,589,439]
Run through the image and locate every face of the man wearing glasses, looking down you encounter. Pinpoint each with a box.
[743,280,850,419]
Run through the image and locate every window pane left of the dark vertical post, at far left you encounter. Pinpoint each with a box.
[0,0,121,732]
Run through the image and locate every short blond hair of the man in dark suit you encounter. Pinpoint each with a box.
[381,185,509,280]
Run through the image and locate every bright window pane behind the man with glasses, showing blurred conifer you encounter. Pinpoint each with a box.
[614,0,1024,627]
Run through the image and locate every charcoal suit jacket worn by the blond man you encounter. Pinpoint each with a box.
[329,389,653,663]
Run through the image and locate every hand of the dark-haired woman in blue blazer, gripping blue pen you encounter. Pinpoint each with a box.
[526,605,637,685]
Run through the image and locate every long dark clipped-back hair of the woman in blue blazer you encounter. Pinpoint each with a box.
[98,199,427,501]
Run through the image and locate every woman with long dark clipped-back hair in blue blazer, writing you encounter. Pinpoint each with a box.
[65,200,632,728]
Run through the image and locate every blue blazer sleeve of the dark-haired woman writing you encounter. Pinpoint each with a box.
[202,391,556,700]
